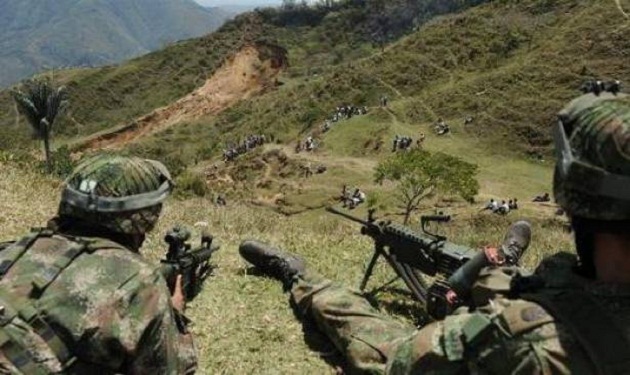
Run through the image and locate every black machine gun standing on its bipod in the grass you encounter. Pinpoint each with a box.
[326,207,478,319]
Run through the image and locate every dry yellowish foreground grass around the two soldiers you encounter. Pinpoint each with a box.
[0,164,570,374]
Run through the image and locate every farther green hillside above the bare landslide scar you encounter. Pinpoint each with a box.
[0,0,492,149]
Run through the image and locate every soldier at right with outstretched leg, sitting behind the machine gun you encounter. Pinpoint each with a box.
[240,92,630,375]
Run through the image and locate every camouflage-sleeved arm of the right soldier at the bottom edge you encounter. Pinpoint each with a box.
[387,300,570,374]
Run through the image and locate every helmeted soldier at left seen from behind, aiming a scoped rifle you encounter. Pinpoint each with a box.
[0,155,196,375]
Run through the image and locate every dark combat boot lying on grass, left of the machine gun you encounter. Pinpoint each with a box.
[238,240,305,286]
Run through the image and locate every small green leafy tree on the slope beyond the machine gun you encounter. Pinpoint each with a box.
[374,149,479,225]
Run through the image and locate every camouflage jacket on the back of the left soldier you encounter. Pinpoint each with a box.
[0,232,196,374]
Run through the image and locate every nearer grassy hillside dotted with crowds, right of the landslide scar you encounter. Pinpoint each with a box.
[87,0,630,220]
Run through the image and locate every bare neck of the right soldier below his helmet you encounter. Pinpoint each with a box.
[594,233,630,284]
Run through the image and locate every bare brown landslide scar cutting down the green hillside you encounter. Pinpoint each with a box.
[77,45,284,149]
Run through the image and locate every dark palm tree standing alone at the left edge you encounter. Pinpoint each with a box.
[12,80,68,173]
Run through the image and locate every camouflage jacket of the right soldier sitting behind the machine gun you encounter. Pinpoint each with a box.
[387,253,630,374]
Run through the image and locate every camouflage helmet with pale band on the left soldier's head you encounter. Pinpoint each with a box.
[59,155,173,234]
